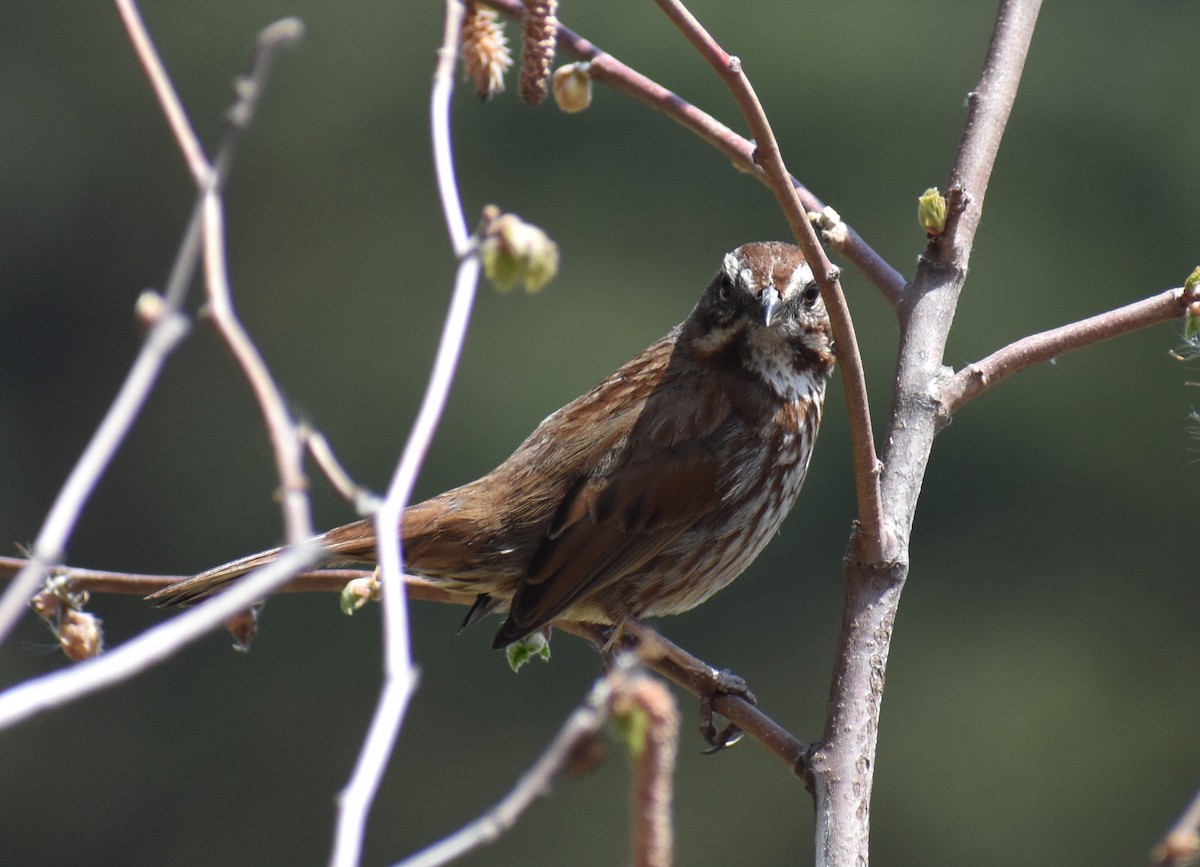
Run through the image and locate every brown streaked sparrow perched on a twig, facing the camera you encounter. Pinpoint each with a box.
[150,237,834,647]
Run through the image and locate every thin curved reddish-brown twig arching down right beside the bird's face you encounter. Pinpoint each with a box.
[656,0,884,561]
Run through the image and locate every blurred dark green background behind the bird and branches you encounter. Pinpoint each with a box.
[0,0,1200,866]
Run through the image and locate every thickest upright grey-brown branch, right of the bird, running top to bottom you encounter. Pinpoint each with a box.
[810,0,1039,866]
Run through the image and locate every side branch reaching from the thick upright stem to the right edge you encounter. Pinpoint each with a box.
[940,288,1200,419]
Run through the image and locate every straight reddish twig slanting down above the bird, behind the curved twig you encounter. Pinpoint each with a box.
[480,0,905,304]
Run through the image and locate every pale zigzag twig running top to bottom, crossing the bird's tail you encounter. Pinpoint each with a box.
[330,0,480,867]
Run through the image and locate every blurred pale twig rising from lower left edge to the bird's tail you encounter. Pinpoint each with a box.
[0,543,320,730]
